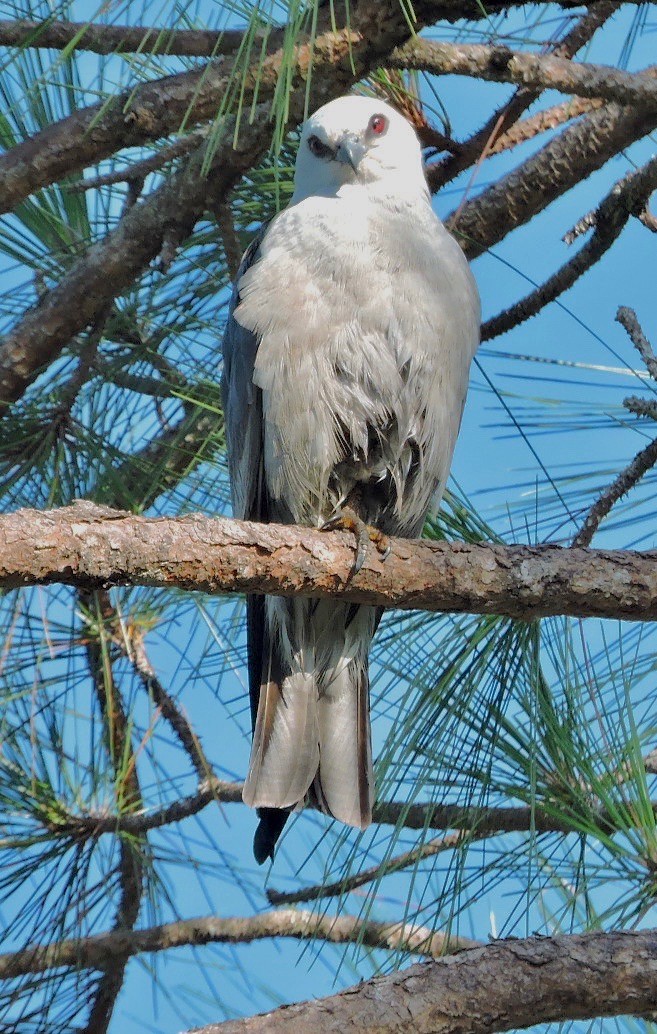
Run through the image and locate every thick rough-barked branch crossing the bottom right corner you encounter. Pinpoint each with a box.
[189,930,657,1034]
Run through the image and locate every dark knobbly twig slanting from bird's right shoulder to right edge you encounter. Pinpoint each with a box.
[481,158,657,341]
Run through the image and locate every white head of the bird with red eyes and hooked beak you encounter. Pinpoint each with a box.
[293,95,427,203]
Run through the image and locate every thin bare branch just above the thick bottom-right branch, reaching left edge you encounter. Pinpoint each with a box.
[0,909,478,980]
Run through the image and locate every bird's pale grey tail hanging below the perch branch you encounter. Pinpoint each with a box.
[243,598,378,854]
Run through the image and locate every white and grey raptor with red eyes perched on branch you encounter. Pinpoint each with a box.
[221,94,480,863]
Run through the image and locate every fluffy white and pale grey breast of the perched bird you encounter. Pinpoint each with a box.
[235,188,479,529]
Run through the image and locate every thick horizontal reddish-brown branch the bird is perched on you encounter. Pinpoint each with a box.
[0,503,657,620]
